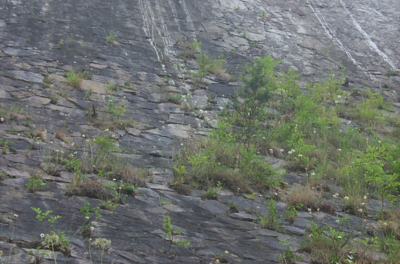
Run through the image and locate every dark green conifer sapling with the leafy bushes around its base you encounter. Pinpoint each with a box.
[176,57,279,191]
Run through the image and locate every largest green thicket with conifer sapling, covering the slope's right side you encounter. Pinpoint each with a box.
[173,54,400,263]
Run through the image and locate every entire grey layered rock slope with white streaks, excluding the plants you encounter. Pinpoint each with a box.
[0,0,400,263]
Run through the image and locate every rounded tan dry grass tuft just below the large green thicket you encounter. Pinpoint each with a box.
[285,185,321,210]
